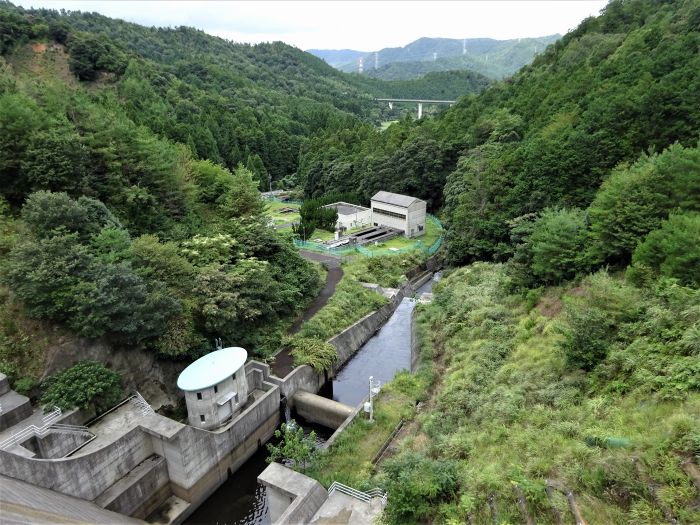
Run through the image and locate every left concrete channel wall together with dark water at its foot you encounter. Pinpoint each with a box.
[0,256,434,524]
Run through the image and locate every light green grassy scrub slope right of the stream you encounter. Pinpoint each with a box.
[374,263,700,525]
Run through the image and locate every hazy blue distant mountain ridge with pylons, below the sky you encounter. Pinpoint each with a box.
[308,34,561,80]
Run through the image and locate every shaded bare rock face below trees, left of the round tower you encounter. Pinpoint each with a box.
[42,337,187,409]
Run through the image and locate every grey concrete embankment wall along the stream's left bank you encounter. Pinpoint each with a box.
[0,256,442,523]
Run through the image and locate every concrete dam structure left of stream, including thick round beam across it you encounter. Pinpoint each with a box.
[0,256,438,524]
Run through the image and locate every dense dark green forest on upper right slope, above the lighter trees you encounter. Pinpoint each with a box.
[299,0,700,264]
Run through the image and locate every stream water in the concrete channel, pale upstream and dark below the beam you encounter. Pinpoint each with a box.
[185,274,440,525]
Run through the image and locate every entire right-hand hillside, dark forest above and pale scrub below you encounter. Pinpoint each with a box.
[314,0,700,525]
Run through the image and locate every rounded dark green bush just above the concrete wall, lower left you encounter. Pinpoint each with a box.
[41,361,124,413]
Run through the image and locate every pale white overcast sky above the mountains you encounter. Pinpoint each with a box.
[11,0,607,51]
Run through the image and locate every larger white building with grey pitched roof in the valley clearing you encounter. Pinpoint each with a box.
[372,191,426,238]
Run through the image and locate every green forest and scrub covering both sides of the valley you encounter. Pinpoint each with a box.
[0,0,700,524]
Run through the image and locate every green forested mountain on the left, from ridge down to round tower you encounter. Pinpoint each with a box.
[0,2,487,372]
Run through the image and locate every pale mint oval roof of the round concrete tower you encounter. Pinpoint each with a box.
[177,346,248,392]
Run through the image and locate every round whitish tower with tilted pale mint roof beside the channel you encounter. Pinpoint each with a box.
[177,347,248,430]
